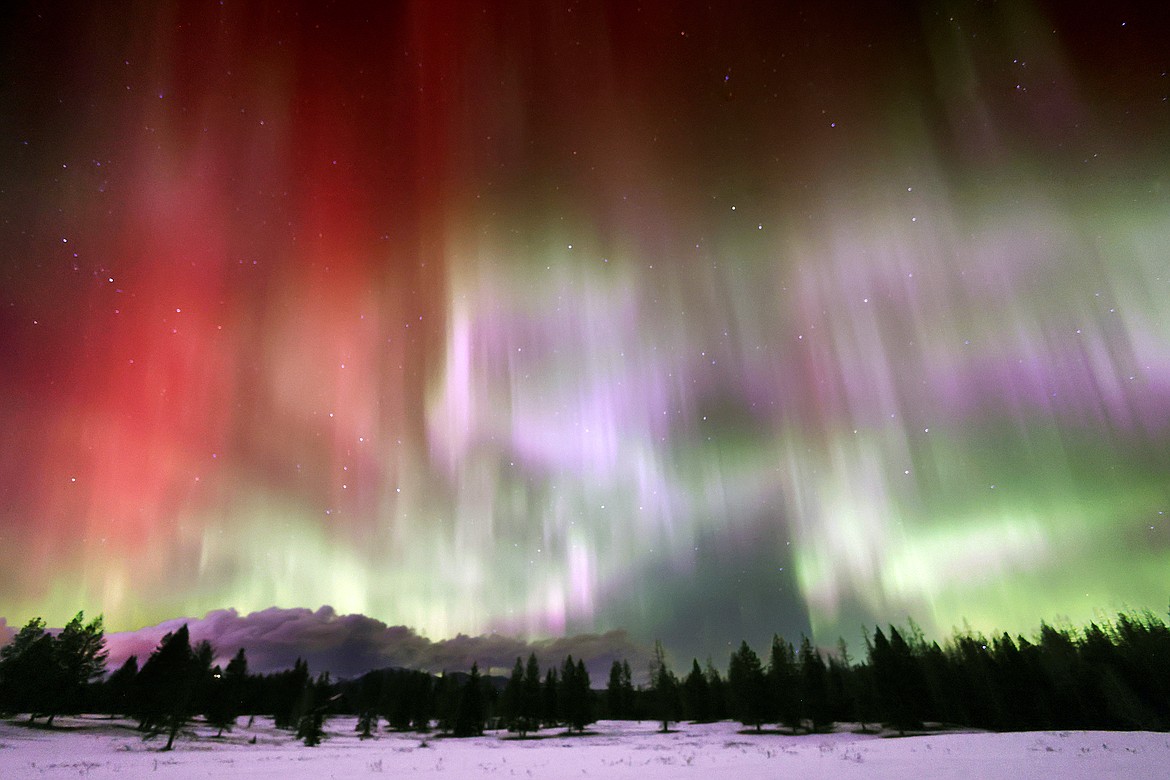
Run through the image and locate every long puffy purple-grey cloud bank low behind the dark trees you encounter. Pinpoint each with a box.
[102,606,651,686]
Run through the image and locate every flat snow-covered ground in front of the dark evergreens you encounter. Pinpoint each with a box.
[0,718,1170,780]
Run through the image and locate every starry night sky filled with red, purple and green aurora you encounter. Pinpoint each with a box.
[0,0,1170,660]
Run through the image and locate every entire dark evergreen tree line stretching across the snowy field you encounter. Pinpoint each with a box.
[0,612,1170,750]
